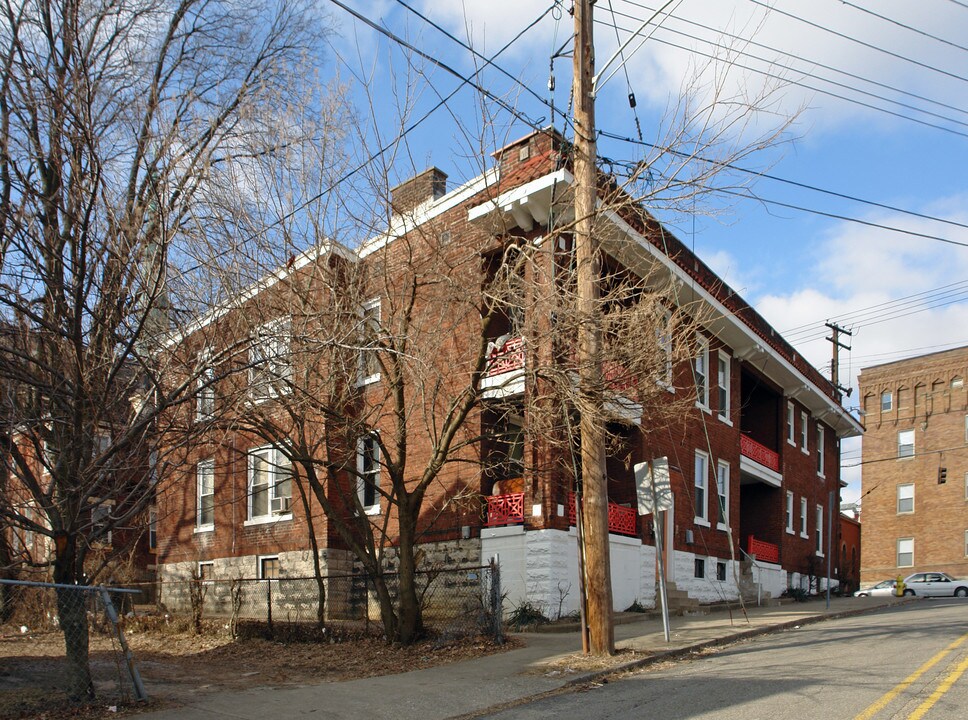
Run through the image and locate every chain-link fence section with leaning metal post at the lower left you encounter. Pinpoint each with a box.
[0,580,147,717]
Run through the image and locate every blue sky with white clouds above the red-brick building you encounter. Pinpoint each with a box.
[327,0,968,500]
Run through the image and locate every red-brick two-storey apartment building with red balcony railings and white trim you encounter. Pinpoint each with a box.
[158,132,861,612]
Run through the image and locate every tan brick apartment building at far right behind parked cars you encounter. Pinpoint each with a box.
[858,347,968,583]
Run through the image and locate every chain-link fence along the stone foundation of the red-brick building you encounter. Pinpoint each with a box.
[136,564,502,640]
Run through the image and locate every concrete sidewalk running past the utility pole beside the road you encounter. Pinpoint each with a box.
[144,598,910,720]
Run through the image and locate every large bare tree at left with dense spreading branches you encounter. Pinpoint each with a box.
[0,0,320,700]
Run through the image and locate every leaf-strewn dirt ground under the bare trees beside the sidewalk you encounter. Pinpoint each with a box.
[0,617,520,720]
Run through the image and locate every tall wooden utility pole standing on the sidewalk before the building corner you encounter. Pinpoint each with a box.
[574,0,615,655]
